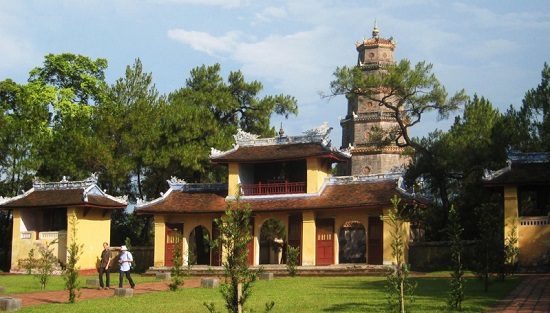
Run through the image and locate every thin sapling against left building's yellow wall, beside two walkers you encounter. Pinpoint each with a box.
[63,212,84,303]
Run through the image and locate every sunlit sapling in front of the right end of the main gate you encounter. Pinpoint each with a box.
[380,196,416,313]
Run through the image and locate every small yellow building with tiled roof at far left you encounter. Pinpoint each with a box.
[0,175,127,274]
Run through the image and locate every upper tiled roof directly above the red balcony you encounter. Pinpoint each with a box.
[211,142,348,164]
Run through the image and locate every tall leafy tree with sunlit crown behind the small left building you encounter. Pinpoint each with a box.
[29,53,107,180]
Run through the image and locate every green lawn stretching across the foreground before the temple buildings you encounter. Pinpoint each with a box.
[0,275,522,313]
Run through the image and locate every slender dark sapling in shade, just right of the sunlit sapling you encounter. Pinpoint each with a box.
[447,206,464,310]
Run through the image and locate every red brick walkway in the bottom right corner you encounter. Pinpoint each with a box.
[488,274,550,313]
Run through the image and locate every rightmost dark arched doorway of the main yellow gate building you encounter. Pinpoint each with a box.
[338,221,367,264]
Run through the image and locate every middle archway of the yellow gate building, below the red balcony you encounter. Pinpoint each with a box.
[260,218,287,264]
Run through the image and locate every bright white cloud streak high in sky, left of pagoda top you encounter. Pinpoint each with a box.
[168,29,241,56]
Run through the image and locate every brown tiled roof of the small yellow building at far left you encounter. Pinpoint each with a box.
[0,189,127,210]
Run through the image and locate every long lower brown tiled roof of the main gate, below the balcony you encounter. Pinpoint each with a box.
[136,180,422,214]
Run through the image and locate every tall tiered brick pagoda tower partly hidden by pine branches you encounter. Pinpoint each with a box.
[337,22,410,176]
